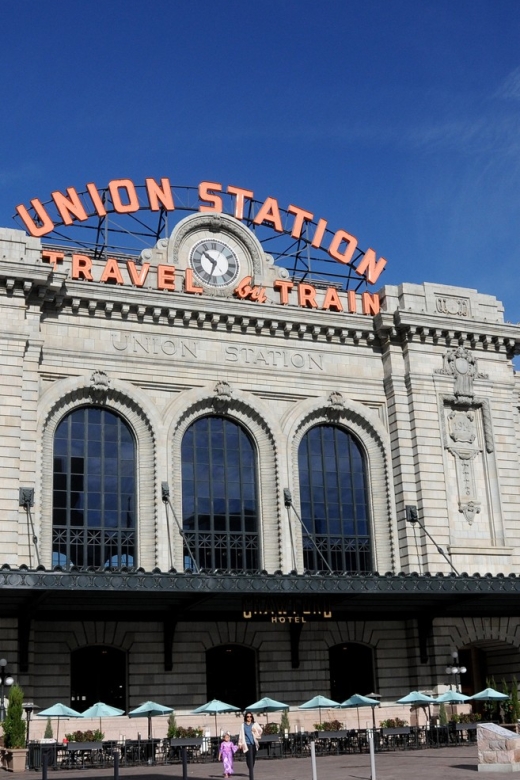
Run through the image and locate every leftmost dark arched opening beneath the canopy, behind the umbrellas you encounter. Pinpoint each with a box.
[70,645,126,712]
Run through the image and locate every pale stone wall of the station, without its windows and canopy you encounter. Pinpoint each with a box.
[0,216,520,709]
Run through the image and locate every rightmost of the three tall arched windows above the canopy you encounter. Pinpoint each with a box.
[298,425,372,572]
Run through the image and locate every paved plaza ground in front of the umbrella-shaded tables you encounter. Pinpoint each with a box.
[8,745,514,780]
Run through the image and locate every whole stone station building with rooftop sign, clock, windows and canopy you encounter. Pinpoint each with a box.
[0,180,520,712]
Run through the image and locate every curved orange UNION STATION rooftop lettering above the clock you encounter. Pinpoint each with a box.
[16,178,386,284]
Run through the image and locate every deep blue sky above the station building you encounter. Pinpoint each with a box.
[0,0,520,322]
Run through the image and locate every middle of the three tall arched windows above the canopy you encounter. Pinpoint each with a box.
[182,416,259,571]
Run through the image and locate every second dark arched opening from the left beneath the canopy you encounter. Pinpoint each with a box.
[206,645,257,710]
